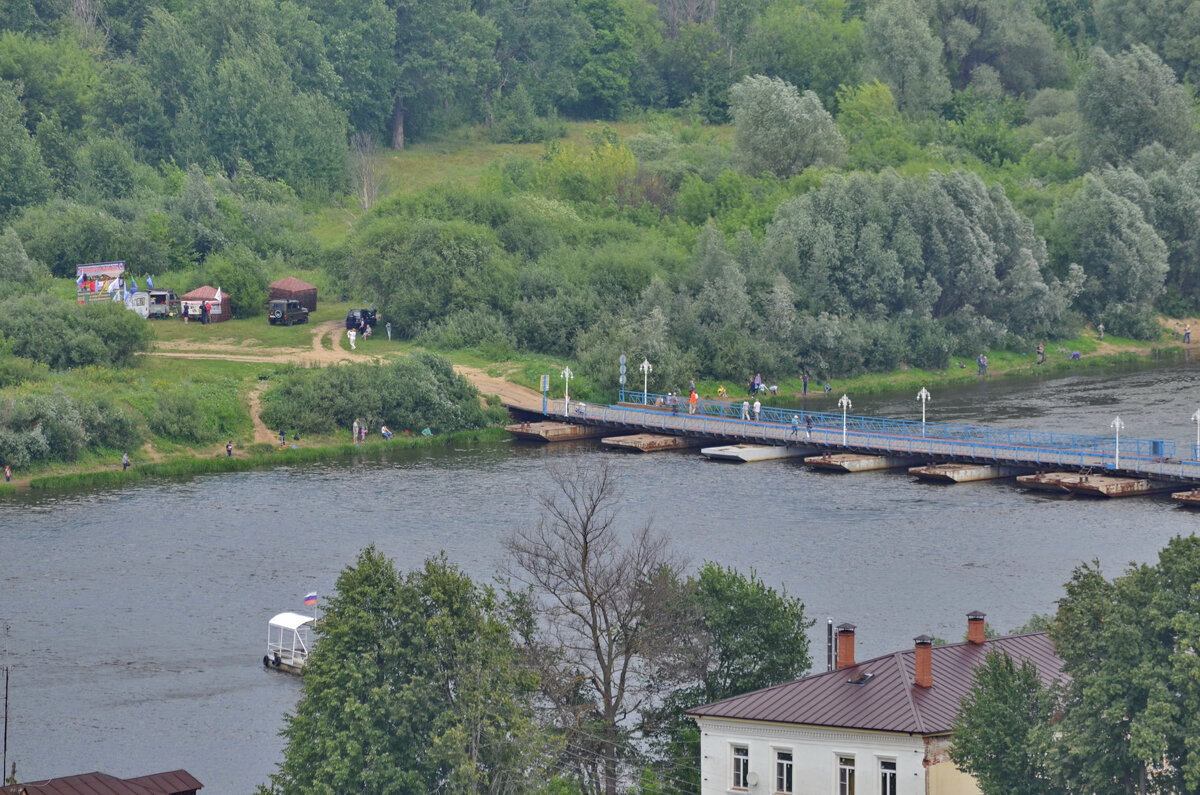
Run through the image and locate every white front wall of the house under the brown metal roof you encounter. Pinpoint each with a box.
[698,718,925,795]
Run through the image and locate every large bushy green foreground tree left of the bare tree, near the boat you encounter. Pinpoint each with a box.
[260,546,545,795]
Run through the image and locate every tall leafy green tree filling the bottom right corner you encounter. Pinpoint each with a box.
[1050,536,1200,794]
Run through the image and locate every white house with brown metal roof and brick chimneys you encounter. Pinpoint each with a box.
[688,611,1062,795]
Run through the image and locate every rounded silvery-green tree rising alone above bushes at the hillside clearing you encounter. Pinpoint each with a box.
[730,74,846,177]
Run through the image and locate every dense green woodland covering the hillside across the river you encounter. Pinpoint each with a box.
[0,0,1200,389]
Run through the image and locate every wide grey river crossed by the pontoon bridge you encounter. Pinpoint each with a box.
[0,365,1200,795]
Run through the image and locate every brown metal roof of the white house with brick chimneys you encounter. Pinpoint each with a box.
[688,632,1062,735]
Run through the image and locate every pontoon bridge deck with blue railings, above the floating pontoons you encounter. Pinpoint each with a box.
[544,393,1200,485]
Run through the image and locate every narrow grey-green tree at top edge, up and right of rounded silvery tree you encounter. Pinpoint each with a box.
[863,0,950,115]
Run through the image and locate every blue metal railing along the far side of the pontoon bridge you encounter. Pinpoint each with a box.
[618,389,1176,460]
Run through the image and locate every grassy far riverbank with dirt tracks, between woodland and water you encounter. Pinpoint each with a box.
[0,295,1184,494]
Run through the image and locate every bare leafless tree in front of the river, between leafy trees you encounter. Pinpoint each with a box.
[506,459,682,795]
